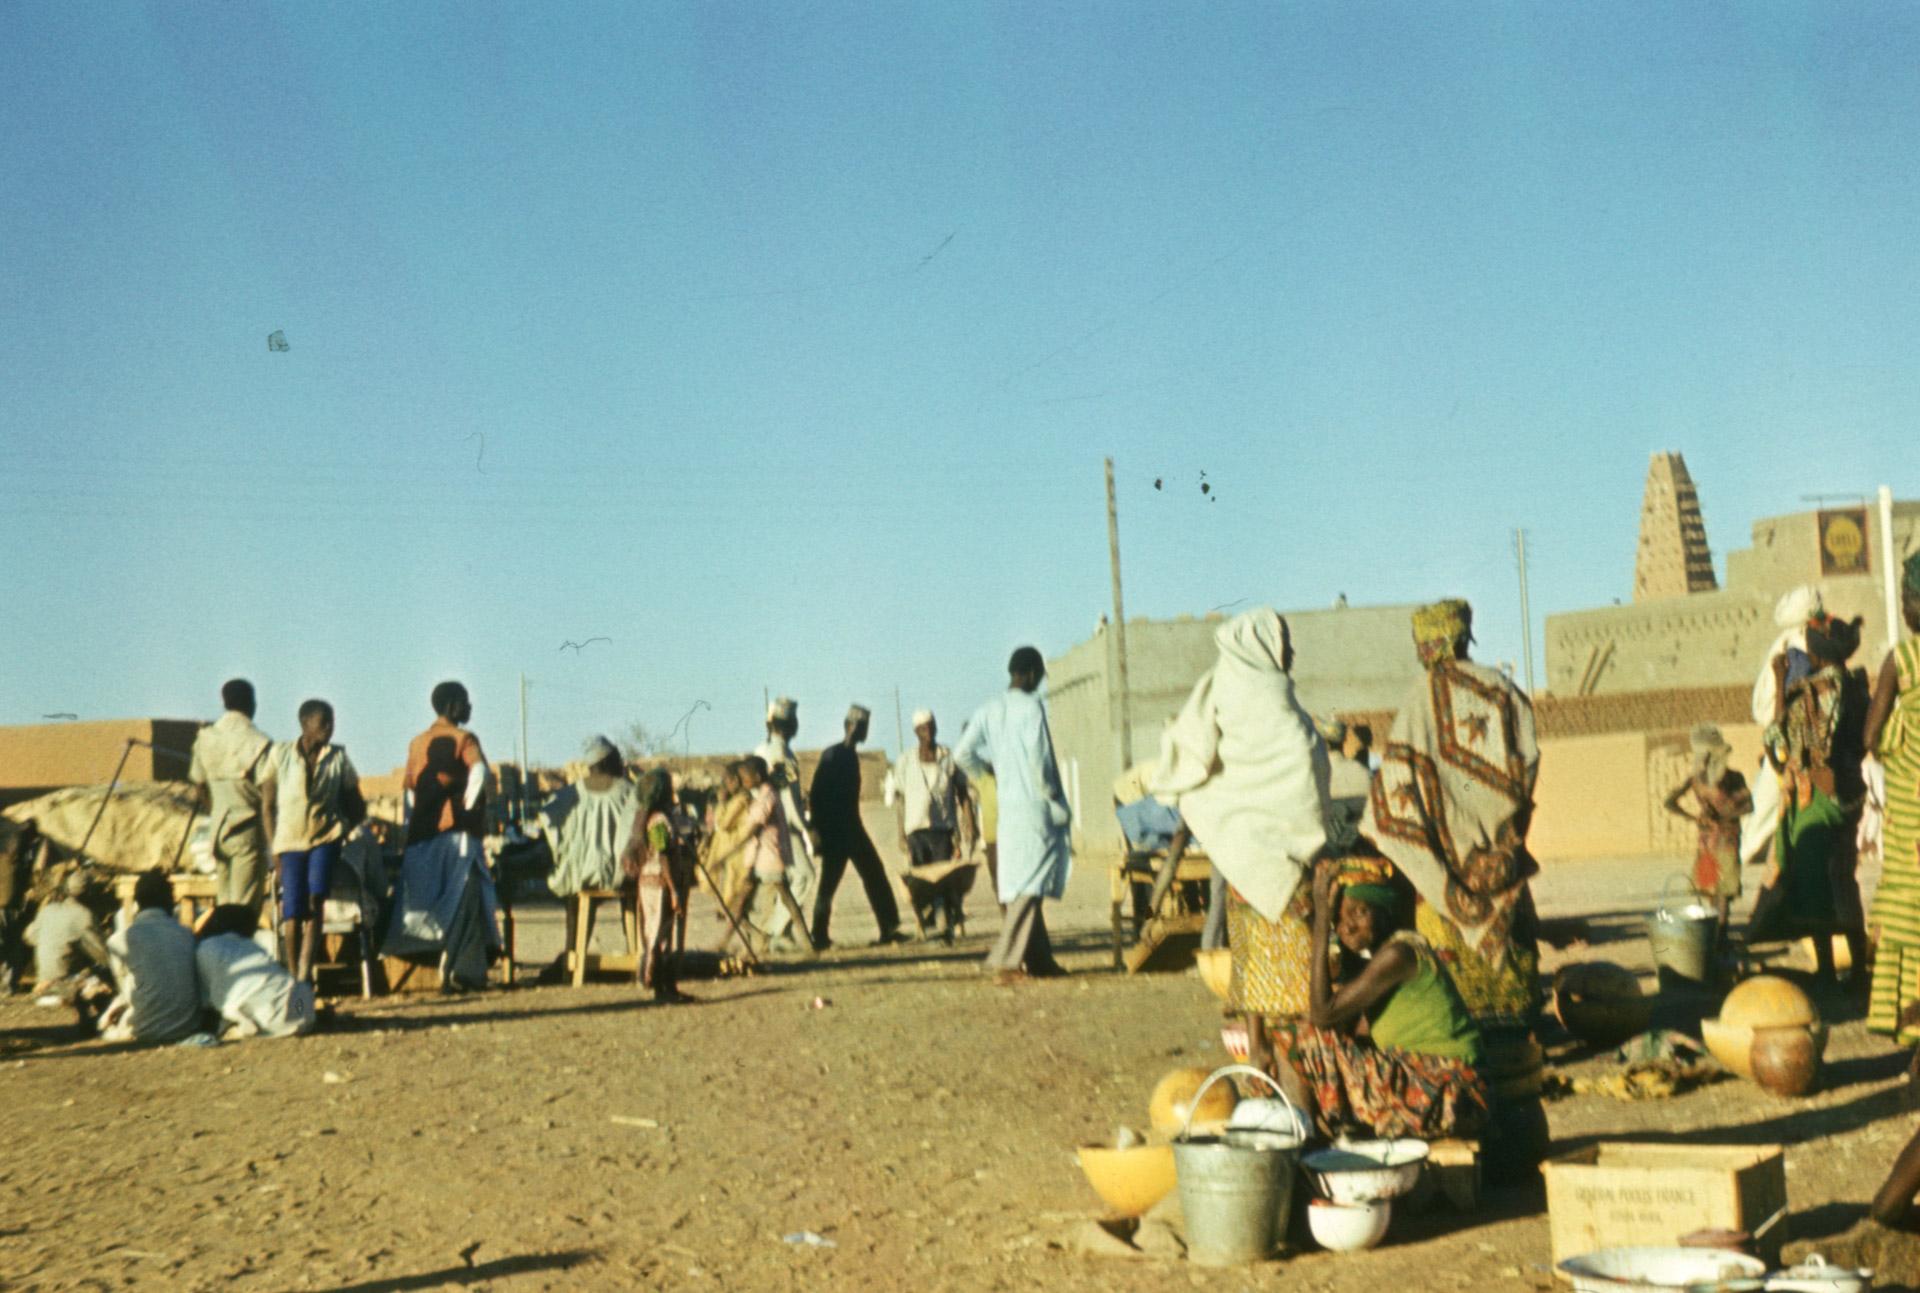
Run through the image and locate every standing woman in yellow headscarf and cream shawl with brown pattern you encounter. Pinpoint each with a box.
[1359,599,1540,1032]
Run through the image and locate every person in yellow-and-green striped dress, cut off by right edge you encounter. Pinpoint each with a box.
[1866,553,1920,1089]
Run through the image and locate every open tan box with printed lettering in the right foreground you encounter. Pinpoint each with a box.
[1544,1141,1788,1264]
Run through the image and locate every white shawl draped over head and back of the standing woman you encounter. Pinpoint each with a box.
[1152,607,1332,920]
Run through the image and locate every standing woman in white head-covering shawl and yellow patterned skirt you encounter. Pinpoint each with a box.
[1152,607,1331,1062]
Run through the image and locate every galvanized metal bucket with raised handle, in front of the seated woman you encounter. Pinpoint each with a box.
[1173,1064,1300,1266]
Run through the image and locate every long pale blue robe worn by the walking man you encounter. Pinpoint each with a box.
[954,688,1073,903]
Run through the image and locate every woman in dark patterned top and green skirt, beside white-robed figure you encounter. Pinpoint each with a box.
[1747,611,1868,982]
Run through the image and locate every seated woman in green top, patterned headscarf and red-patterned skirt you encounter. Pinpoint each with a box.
[1288,857,1488,1139]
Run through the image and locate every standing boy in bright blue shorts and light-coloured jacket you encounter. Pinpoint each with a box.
[261,699,367,984]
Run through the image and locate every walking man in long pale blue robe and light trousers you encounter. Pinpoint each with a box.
[954,646,1073,986]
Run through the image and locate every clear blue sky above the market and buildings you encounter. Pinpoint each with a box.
[0,0,1920,768]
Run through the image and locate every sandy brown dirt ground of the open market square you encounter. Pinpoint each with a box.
[0,845,1912,1293]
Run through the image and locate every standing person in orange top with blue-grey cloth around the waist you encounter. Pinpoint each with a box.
[382,682,501,991]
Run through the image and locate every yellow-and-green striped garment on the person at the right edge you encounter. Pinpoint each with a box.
[1866,638,1920,1045]
